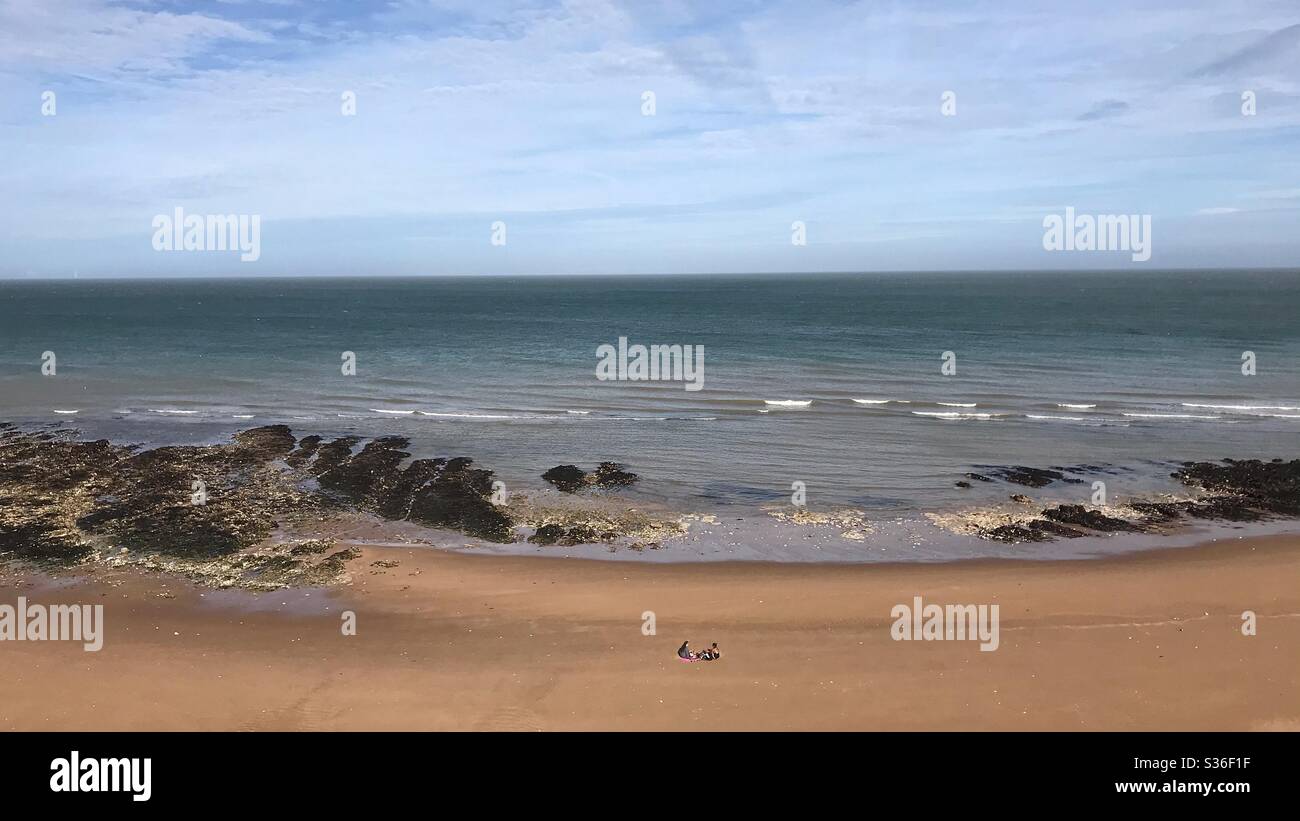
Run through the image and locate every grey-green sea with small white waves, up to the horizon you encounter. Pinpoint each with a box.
[0,272,1300,513]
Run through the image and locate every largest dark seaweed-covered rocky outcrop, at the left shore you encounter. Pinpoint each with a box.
[0,425,514,575]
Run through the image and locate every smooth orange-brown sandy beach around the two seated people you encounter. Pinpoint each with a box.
[0,537,1300,730]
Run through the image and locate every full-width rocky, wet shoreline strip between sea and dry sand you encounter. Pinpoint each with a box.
[0,422,1300,576]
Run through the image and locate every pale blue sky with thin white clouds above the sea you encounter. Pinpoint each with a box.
[0,0,1300,278]
